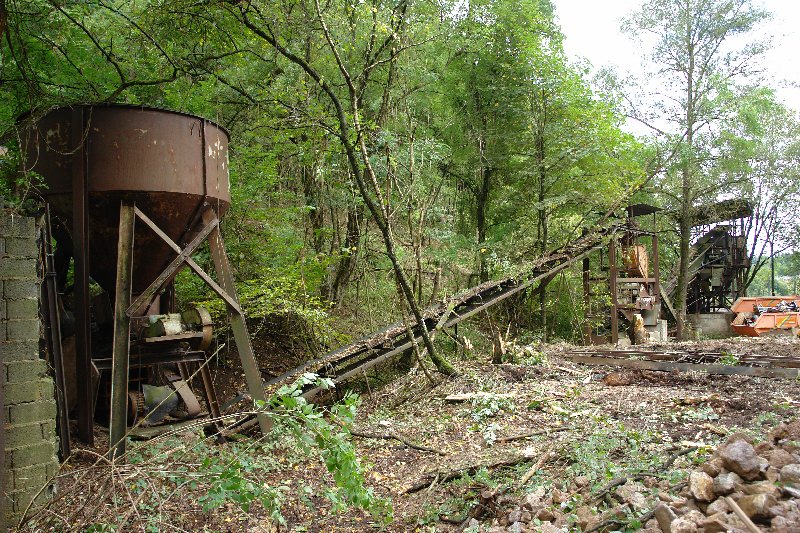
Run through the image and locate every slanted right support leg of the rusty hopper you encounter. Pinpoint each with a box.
[203,209,272,435]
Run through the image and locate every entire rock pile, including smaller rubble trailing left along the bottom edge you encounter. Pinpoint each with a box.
[464,420,800,533]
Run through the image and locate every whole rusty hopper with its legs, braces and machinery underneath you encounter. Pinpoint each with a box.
[25,105,268,456]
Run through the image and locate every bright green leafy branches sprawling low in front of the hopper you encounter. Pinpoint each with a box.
[116,373,392,524]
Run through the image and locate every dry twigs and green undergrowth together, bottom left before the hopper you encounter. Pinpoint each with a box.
[23,374,392,531]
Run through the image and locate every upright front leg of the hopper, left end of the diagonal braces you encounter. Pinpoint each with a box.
[108,200,136,460]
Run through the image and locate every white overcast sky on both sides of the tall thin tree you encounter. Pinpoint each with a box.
[553,0,800,110]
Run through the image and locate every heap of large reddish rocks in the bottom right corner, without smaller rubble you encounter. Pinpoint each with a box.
[654,420,800,533]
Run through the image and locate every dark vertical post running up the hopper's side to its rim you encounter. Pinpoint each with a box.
[70,107,94,446]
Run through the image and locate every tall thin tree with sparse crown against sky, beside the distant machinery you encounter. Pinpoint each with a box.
[627,0,768,336]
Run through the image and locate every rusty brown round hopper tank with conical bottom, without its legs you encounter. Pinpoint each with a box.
[25,105,230,294]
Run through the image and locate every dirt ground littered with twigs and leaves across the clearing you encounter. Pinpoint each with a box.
[23,338,800,532]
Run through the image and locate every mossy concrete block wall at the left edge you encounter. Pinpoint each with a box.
[0,209,58,525]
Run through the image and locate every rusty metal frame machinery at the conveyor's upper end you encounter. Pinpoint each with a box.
[583,204,666,344]
